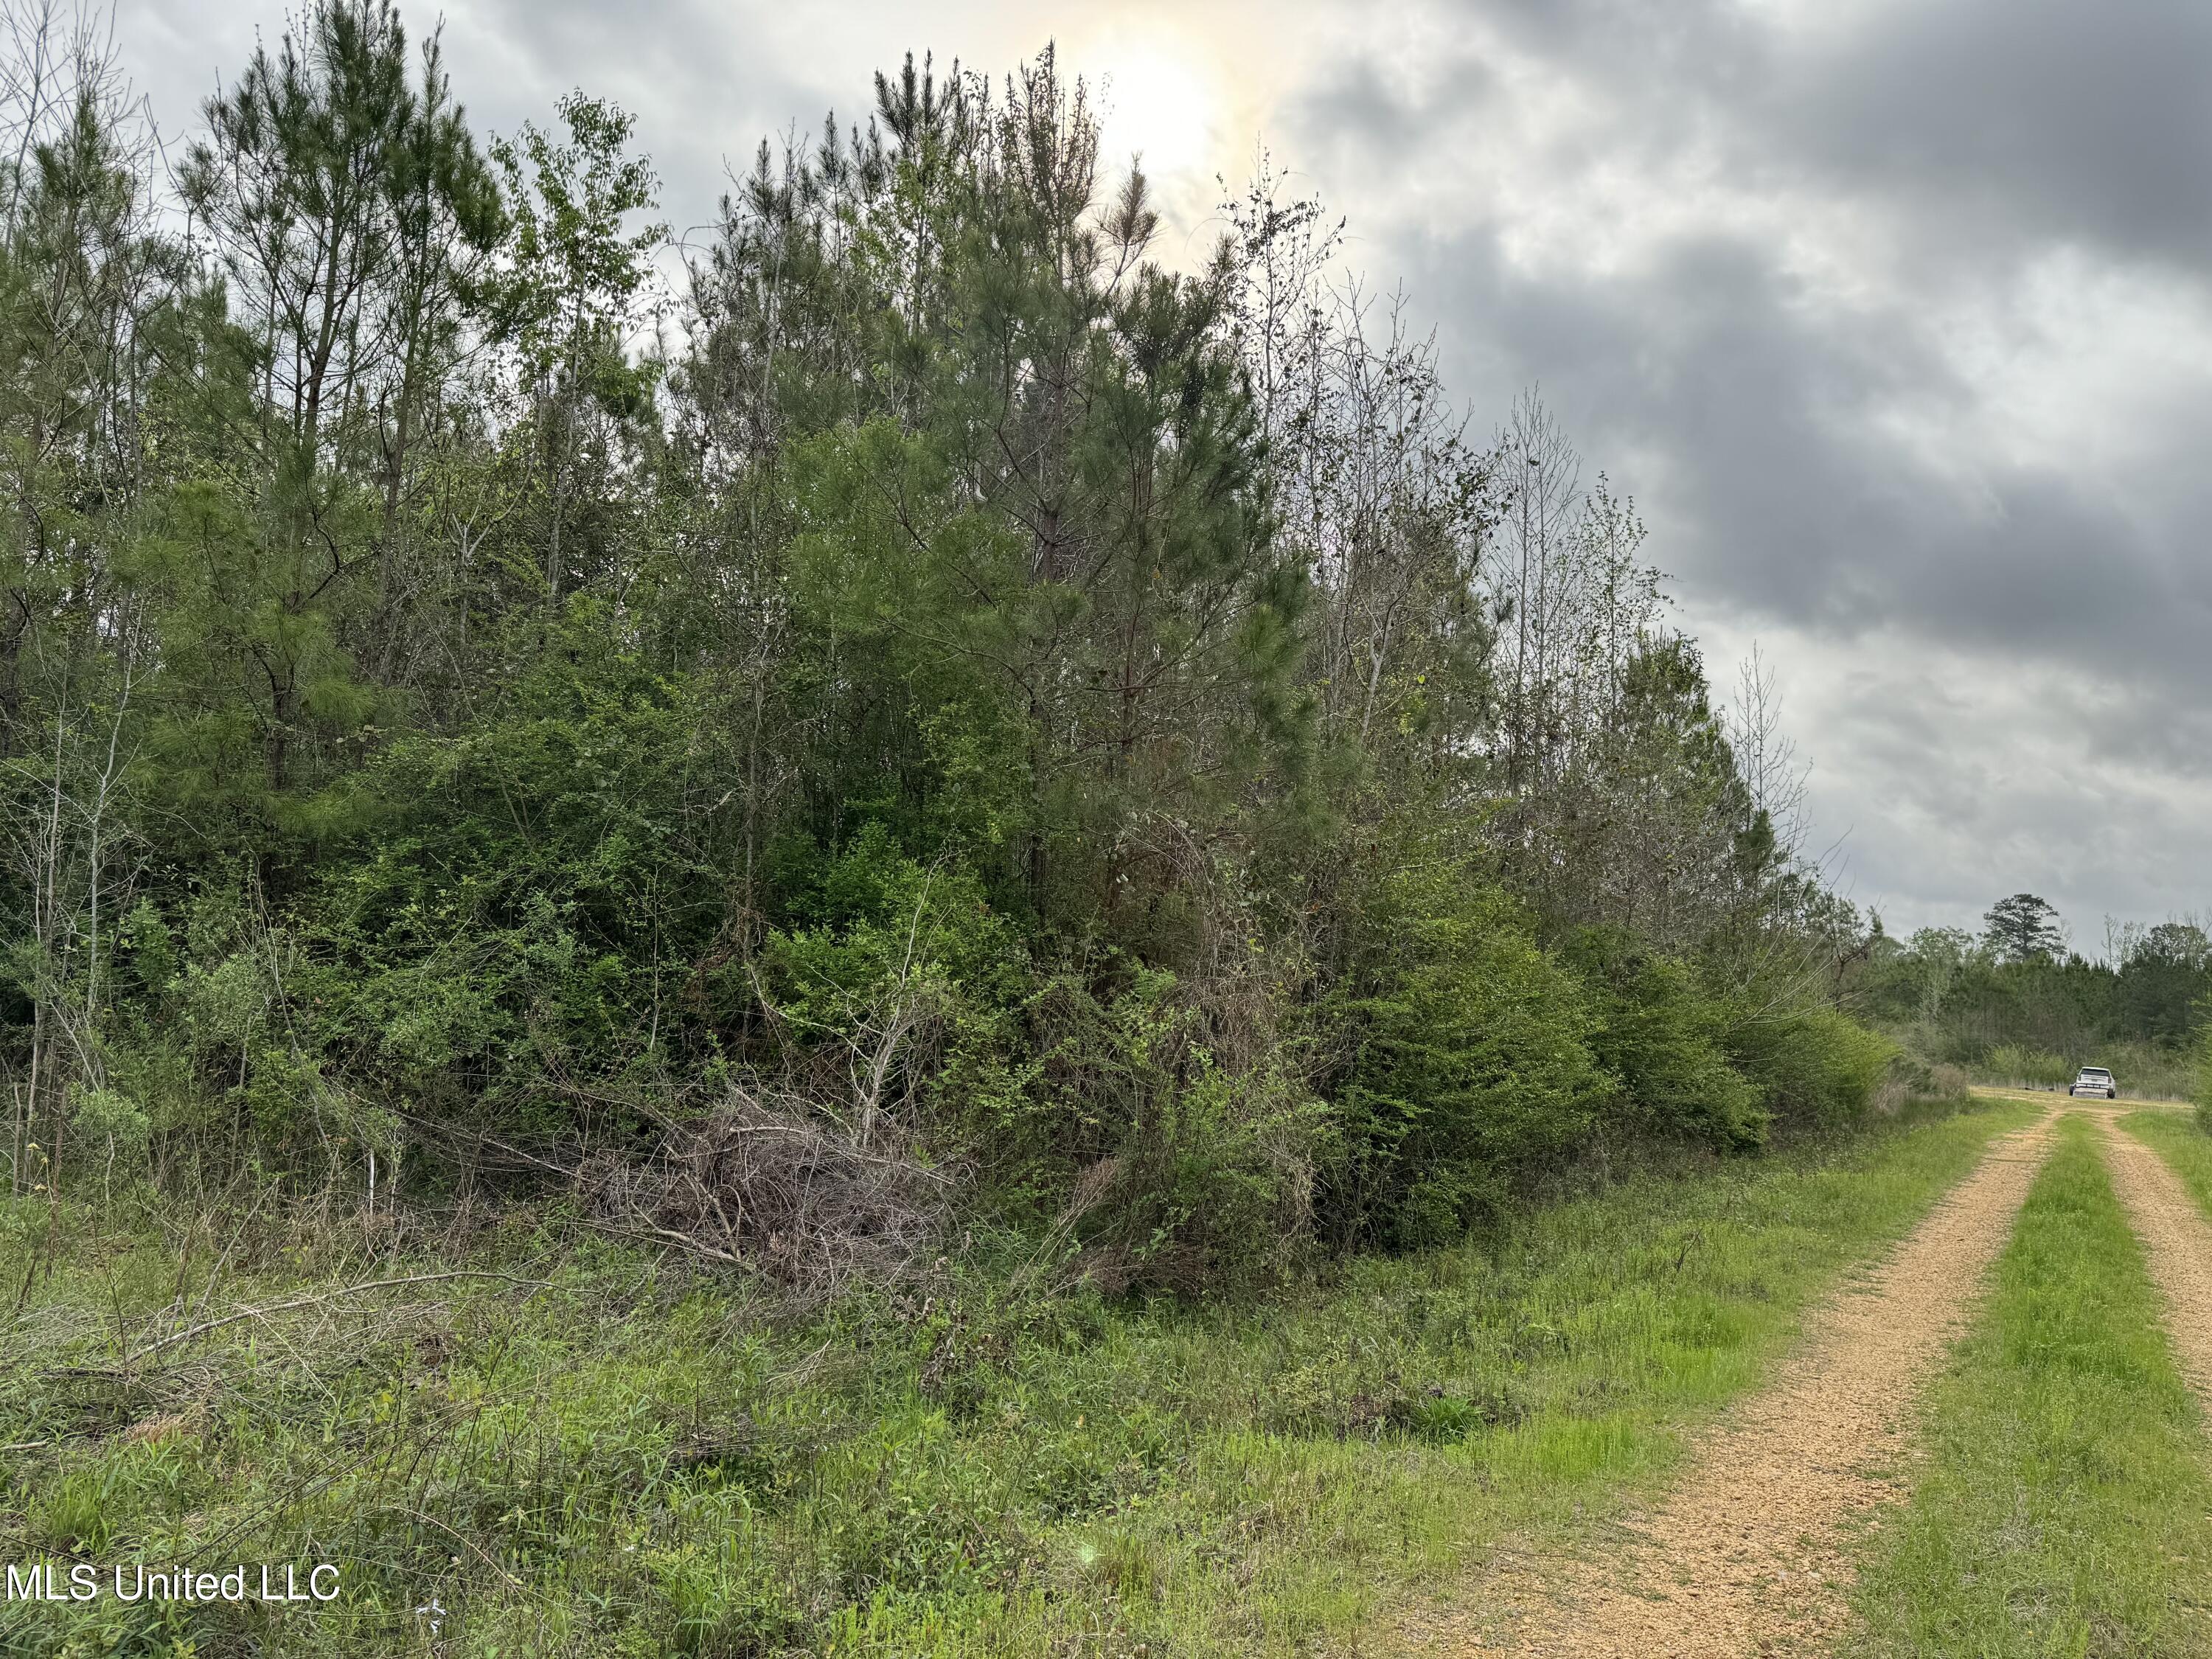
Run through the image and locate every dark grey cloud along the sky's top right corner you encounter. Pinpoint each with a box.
[1455,0,2212,261]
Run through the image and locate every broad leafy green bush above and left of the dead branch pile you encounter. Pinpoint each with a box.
[276,628,717,1124]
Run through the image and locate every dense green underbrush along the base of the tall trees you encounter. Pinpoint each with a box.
[15,830,1902,1298]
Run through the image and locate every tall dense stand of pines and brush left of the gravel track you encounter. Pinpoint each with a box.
[0,0,1902,1285]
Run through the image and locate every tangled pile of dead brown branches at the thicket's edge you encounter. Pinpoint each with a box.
[577,1091,953,1296]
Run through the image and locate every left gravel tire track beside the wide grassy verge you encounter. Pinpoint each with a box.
[1460,1108,2062,1659]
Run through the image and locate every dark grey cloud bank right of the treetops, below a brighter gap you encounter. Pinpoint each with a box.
[1380,218,2205,668]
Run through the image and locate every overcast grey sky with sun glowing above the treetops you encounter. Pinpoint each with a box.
[117,0,2212,949]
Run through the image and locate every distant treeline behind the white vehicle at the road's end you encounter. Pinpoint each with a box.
[1854,894,2212,1095]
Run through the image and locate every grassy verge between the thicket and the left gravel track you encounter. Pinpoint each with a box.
[0,1104,2033,1659]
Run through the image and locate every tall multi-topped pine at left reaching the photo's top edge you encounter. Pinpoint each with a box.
[153,0,507,856]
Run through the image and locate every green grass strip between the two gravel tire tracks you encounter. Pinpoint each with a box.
[1851,1119,2212,1659]
